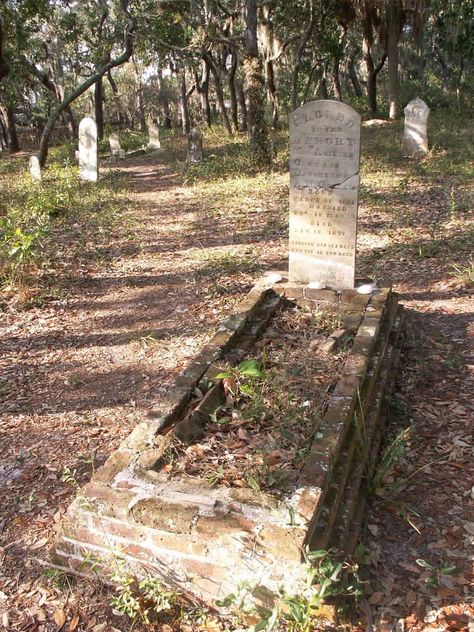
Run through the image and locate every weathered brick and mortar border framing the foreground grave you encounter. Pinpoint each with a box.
[52,279,404,606]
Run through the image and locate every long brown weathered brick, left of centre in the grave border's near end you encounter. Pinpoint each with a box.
[130,498,198,533]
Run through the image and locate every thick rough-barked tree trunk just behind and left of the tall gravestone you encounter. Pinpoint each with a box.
[243,0,273,164]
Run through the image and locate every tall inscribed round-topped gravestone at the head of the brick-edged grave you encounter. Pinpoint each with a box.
[289,100,361,289]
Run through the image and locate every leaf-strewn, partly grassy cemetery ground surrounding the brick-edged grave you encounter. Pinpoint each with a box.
[0,115,474,632]
